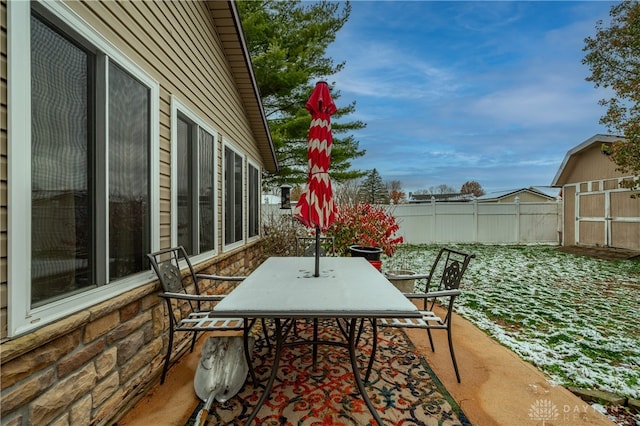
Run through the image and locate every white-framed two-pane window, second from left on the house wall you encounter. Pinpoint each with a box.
[171,98,218,256]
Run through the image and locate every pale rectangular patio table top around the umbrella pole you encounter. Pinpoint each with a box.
[212,257,419,318]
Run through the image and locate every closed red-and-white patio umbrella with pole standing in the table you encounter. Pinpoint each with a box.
[293,81,337,277]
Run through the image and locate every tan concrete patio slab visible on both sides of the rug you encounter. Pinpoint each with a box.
[117,310,613,426]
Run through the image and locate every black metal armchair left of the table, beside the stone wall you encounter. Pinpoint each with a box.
[147,246,258,384]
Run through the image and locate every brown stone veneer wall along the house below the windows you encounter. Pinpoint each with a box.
[0,244,262,426]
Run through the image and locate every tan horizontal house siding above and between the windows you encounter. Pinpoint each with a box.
[62,2,264,247]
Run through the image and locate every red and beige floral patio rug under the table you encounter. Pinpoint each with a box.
[187,321,470,426]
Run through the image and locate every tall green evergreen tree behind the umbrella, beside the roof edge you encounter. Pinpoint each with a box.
[237,0,365,187]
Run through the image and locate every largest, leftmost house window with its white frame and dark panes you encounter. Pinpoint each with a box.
[8,2,159,335]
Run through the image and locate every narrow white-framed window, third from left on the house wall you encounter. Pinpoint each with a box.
[223,143,244,249]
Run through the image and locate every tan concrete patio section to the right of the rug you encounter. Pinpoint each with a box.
[407,306,613,426]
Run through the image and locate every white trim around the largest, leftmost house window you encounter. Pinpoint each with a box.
[7,0,160,337]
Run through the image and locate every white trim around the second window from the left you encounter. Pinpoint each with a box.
[171,95,220,263]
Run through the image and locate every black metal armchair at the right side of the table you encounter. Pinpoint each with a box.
[380,247,475,383]
